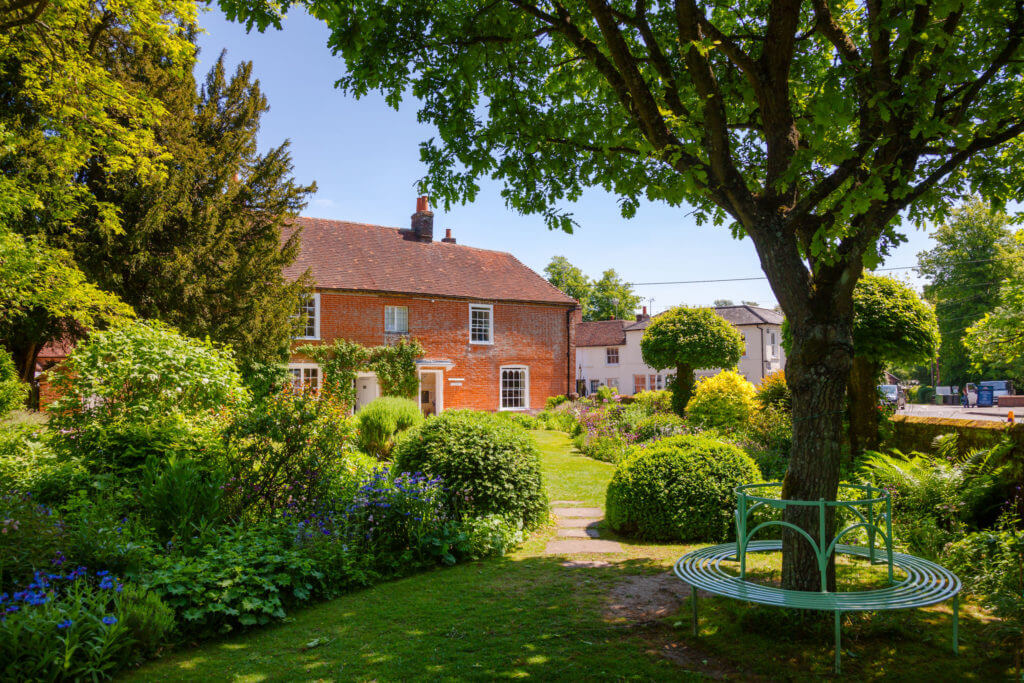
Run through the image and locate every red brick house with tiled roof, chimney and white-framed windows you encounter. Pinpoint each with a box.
[286,197,580,413]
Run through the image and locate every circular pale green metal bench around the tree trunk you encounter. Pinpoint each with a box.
[675,482,962,674]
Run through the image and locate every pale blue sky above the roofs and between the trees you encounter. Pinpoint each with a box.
[196,10,931,311]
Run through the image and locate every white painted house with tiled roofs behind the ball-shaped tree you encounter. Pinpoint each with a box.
[575,305,785,395]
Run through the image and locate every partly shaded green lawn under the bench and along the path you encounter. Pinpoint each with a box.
[128,432,1011,681]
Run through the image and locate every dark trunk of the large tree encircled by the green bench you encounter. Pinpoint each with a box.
[782,307,852,591]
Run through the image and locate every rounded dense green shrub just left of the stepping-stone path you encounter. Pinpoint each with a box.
[394,411,548,527]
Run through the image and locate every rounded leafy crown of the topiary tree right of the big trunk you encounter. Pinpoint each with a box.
[853,275,939,362]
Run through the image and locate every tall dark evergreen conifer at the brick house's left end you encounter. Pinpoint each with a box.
[71,52,315,362]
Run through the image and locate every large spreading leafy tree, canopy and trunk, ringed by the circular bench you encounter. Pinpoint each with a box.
[220,0,1024,590]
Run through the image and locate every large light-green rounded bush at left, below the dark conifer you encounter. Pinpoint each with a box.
[50,321,248,432]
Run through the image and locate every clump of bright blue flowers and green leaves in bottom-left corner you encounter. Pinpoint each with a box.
[0,570,173,681]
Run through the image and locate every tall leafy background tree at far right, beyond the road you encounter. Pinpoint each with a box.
[918,199,1021,385]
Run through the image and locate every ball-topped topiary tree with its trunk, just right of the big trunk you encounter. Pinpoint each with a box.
[847,275,939,453]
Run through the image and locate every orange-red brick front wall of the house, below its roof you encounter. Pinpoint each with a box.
[293,290,580,411]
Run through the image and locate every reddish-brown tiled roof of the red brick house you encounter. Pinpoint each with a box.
[285,218,575,306]
